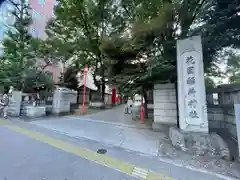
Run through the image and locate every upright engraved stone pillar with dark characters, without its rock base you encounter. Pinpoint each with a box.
[177,36,208,133]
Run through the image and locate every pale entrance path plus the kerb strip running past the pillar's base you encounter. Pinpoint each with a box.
[22,107,240,179]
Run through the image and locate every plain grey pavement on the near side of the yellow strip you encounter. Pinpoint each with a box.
[0,124,137,180]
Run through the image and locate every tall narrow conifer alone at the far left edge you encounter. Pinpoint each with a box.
[1,0,34,89]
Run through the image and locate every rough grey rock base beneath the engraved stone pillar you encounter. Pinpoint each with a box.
[169,127,233,160]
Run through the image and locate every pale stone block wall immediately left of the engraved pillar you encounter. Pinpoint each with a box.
[153,84,177,125]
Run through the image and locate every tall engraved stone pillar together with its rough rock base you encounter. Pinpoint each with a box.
[169,36,232,160]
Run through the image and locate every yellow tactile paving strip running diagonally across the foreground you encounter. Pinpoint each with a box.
[0,121,173,180]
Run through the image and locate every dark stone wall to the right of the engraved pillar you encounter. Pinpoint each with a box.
[207,84,240,140]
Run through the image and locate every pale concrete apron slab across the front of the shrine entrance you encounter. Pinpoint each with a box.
[29,116,159,156]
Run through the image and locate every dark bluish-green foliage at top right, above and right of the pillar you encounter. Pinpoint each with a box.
[190,0,240,69]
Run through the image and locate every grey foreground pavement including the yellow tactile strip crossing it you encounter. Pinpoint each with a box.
[0,121,236,180]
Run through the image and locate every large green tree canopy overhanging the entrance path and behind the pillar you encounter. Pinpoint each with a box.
[36,0,240,96]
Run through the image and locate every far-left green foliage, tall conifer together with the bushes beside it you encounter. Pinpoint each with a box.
[0,0,53,92]
